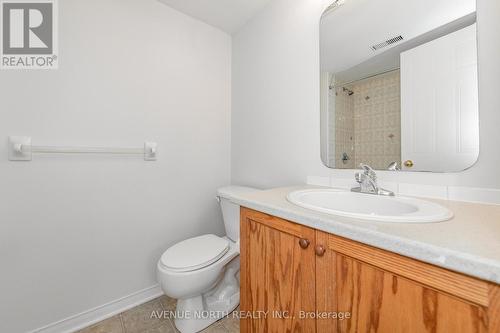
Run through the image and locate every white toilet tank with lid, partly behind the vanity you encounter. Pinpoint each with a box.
[217,186,258,242]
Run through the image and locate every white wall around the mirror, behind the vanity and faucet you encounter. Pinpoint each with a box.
[231,0,500,188]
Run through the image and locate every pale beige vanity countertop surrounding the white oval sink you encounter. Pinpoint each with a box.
[222,186,500,283]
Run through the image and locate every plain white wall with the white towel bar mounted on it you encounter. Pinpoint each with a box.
[0,0,231,333]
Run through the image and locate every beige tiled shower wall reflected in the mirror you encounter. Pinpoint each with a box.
[329,70,401,169]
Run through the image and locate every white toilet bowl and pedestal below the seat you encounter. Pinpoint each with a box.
[174,257,240,333]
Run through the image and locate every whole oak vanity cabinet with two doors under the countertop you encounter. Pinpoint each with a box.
[241,208,500,333]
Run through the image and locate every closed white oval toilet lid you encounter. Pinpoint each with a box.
[160,235,229,272]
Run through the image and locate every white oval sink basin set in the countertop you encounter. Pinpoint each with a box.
[287,189,453,223]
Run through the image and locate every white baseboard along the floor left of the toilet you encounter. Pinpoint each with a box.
[29,285,163,333]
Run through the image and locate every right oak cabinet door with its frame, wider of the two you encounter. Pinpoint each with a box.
[317,232,488,333]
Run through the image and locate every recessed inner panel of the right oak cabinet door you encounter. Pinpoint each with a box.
[337,255,486,333]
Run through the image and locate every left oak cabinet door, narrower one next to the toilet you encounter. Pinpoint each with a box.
[240,208,316,333]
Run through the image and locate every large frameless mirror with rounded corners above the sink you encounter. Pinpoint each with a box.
[320,0,479,172]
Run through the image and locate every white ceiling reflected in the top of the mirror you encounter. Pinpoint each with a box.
[320,0,476,73]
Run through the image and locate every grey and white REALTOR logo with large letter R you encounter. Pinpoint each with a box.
[0,0,57,69]
